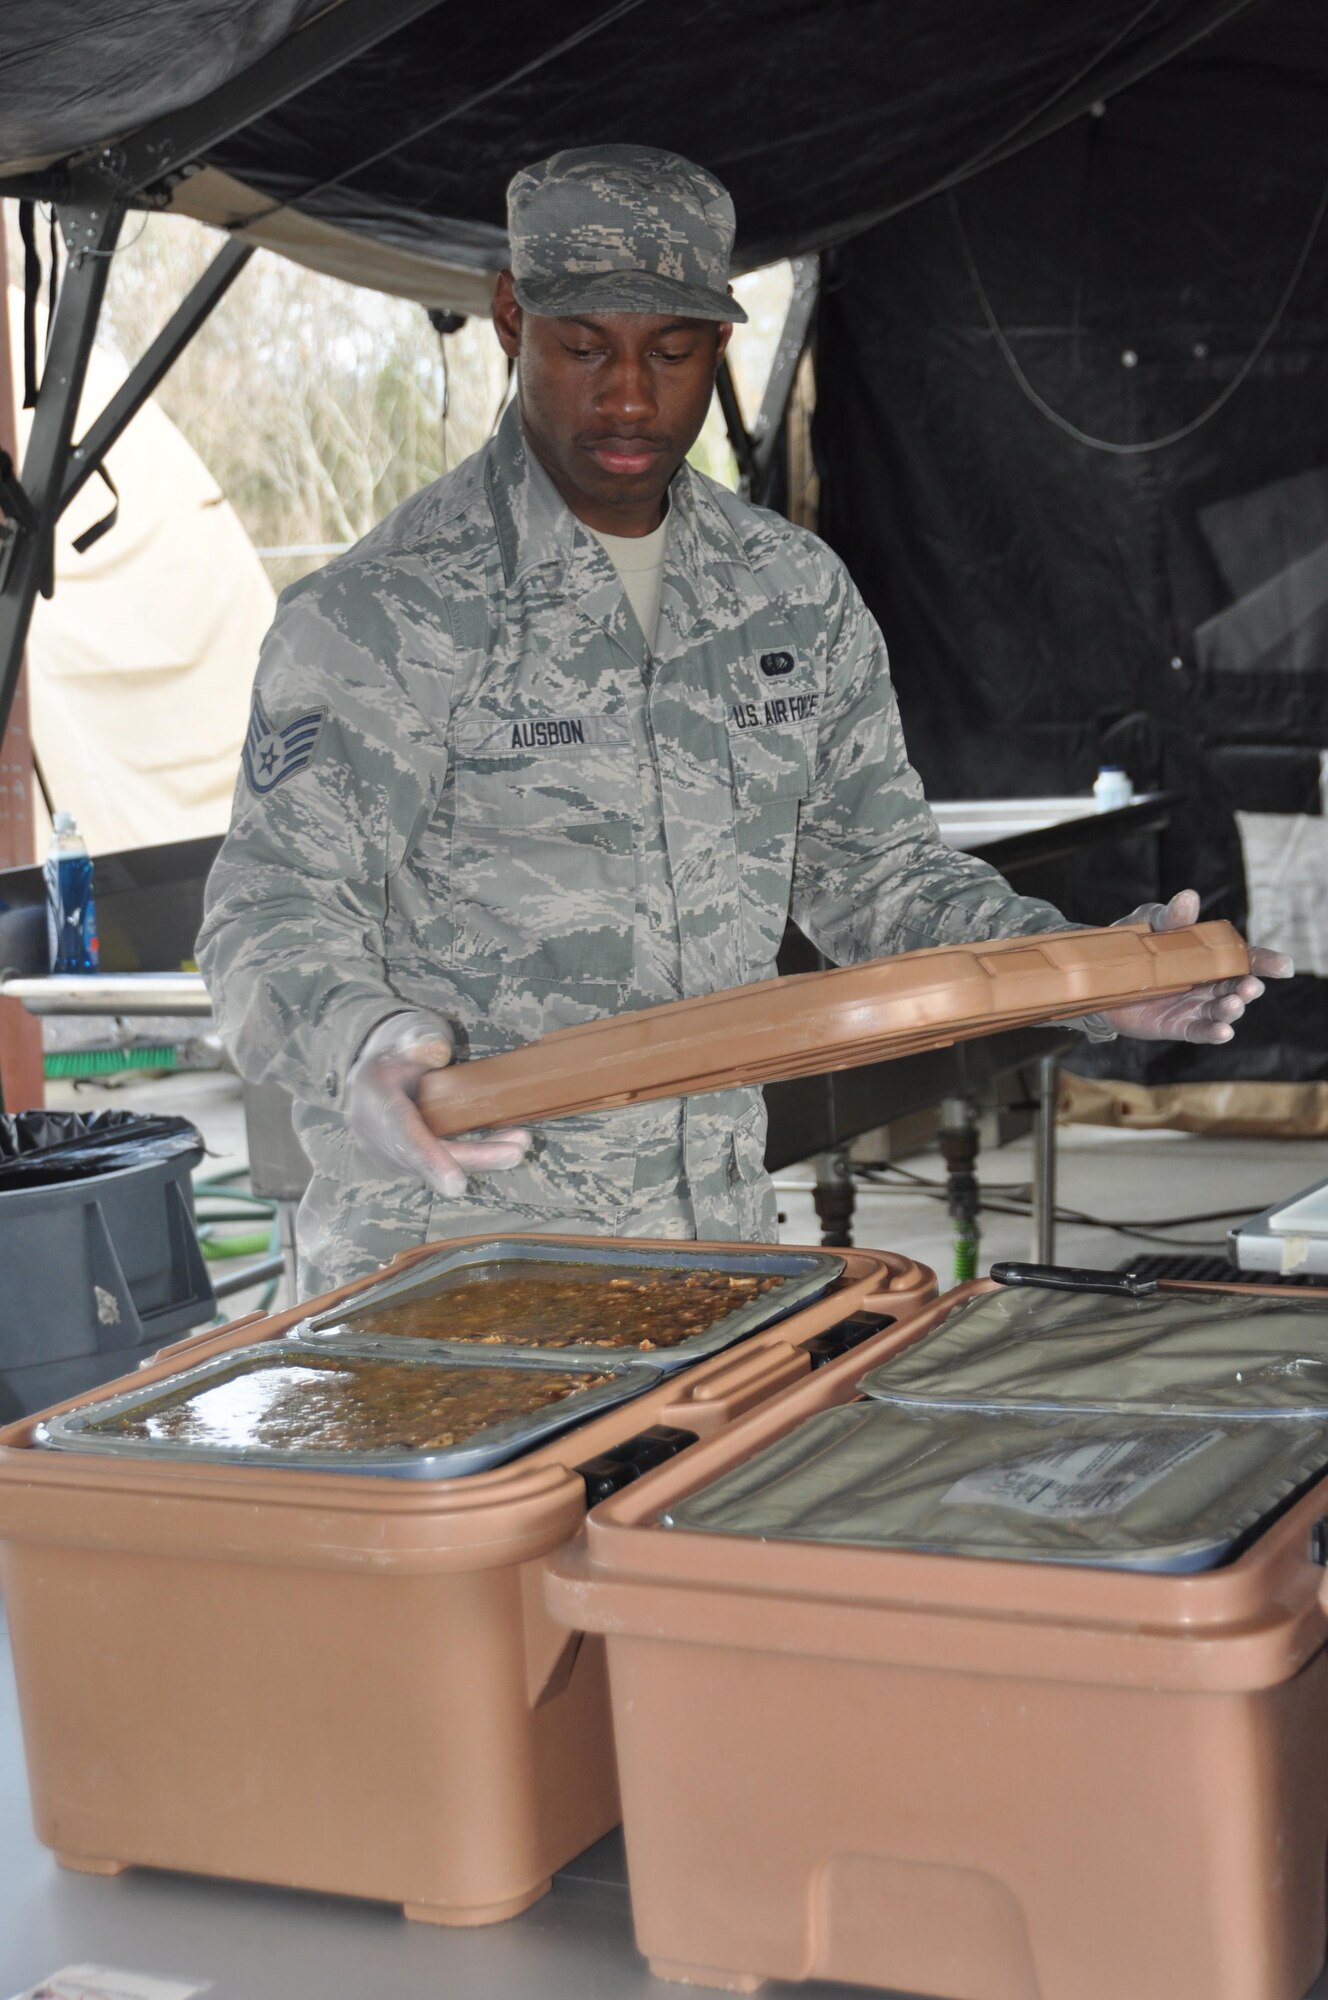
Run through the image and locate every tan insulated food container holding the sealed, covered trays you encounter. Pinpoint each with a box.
[546,1284,1328,2000]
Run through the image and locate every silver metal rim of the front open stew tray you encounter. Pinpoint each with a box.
[34,1340,662,1480]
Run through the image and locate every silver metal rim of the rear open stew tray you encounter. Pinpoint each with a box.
[294,1236,844,1374]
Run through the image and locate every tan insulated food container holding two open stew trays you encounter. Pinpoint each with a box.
[0,1238,936,1924]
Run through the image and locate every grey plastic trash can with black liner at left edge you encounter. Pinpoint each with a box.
[0,1112,216,1422]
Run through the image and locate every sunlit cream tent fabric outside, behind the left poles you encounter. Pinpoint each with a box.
[10,288,276,854]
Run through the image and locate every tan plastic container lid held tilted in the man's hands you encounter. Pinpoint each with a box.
[418,924,1250,1138]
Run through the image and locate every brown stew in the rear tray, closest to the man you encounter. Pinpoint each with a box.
[342,1264,788,1352]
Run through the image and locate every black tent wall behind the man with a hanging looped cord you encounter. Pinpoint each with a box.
[816,0,1328,1076]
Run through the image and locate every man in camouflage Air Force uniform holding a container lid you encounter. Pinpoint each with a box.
[198,146,1274,1296]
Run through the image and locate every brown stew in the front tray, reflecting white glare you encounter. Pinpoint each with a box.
[92,1352,610,1452]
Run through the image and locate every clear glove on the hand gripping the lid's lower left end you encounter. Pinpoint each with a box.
[346,1010,530,1200]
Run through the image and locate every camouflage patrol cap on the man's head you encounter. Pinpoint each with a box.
[508,146,746,322]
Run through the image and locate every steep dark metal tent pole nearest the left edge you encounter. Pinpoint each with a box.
[0,189,124,742]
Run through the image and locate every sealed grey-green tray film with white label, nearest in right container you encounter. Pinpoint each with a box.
[664,1402,1328,1570]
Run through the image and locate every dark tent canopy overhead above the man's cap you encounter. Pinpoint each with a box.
[0,0,1254,304]
